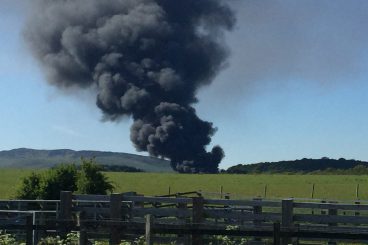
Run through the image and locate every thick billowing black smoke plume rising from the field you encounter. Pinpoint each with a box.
[26,0,235,172]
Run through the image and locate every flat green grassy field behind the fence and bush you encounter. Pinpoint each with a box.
[0,169,368,200]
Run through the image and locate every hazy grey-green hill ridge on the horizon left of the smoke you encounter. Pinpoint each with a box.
[0,148,173,172]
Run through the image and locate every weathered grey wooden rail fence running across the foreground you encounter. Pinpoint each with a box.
[0,192,368,245]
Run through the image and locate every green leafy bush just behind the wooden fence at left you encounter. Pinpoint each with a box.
[16,159,114,200]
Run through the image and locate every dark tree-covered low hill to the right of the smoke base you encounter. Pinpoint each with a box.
[226,157,368,174]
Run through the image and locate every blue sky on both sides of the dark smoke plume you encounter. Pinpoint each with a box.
[0,0,368,168]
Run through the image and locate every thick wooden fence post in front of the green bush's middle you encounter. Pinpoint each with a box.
[59,191,73,237]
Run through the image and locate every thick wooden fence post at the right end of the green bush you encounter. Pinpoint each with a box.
[110,194,122,245]
